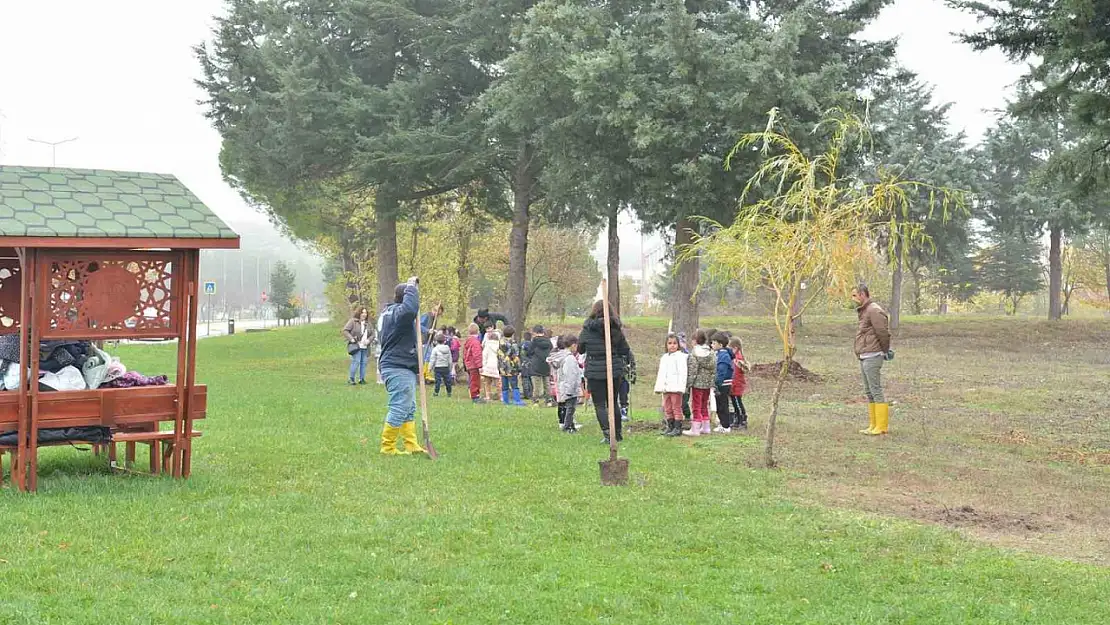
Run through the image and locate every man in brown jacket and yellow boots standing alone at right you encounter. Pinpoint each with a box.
[851,285,890,436]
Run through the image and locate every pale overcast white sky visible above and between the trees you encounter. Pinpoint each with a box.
[0,0,1022,278]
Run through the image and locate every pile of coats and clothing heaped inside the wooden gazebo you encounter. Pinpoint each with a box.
[0,334,169,391]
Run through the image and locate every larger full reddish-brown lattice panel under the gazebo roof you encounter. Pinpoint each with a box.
[44,254,180,337]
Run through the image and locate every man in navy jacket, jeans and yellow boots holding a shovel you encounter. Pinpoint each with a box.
[377,278,424,455]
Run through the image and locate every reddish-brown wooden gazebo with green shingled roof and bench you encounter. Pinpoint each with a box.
[0,167,239,491]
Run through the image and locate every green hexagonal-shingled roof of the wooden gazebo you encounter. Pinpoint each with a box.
[0,165,239,239]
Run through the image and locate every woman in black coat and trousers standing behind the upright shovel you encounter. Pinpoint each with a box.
[578,300,628,445]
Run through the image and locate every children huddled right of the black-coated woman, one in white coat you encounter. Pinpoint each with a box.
[655,330,750,436]
